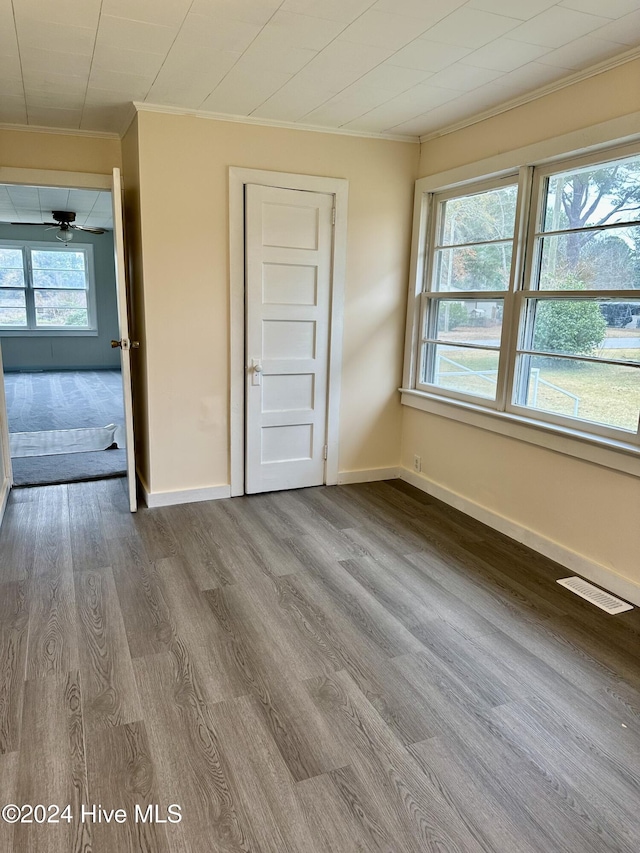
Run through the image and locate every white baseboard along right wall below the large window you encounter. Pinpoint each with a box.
[400,468,640,606]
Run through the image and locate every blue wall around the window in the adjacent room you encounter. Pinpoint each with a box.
[0,223,120,370]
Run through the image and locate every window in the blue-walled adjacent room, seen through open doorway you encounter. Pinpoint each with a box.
[0,240,96,334]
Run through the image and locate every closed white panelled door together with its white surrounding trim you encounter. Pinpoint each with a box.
[229,167,348,495]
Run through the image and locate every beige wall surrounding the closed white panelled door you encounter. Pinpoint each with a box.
[131,112,419,492]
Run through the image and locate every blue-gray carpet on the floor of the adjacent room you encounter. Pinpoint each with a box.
[4,370,126,486]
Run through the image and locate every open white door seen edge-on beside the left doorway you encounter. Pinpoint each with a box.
[111,169,138,512]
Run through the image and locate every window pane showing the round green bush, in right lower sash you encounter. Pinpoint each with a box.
[524,299,640,362]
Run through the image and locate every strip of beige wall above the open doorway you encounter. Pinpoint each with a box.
[0,128,121,175]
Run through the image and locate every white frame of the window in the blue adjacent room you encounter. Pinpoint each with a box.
[0,240,98,337]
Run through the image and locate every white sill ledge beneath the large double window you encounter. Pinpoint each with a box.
[400,388,640,477]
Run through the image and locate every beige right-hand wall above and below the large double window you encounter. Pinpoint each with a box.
[410,62,640,583]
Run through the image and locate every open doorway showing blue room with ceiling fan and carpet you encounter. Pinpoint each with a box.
[0,185,127,486]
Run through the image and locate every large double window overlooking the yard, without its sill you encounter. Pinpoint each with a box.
[412,147,640,444]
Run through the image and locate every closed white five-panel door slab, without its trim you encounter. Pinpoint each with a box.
[245,184,334,493]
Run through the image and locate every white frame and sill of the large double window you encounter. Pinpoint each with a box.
[400,137,640,476]
